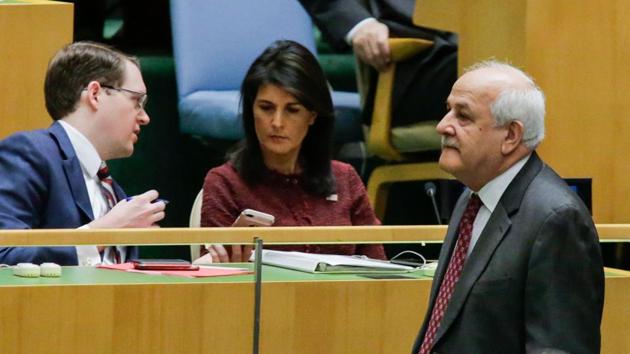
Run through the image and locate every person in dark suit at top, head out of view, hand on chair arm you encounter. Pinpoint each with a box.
[300,0,457,127]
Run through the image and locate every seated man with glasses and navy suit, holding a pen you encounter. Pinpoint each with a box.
[0,42,165,265]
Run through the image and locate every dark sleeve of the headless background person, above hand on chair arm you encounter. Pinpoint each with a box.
[300,0,372,50]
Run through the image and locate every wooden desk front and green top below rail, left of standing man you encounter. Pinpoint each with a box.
[0,264,430,354]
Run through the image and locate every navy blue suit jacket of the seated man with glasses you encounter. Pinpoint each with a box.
[0,122,137,265]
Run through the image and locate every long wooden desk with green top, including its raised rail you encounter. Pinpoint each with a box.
[0,225,630,354]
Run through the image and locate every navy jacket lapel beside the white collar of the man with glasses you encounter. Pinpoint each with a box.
[48,122,94,220]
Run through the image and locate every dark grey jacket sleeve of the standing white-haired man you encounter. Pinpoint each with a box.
[524,205,604,353]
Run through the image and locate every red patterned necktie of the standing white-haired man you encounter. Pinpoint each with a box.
[418,194,481,354]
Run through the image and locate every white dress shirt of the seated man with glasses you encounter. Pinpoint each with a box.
[59,120,126,265]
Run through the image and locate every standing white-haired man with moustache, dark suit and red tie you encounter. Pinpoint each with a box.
[413,62,604,354]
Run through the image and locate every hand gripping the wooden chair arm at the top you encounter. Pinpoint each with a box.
[352,21,391,71]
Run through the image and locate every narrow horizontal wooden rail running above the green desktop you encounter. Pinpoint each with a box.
[0,224,630,246]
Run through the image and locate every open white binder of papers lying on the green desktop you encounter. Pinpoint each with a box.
[251,250,417,273]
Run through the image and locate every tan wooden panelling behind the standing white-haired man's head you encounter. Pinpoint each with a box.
[414,0,630,223]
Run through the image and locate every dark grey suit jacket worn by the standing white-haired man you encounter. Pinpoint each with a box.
[413,153,604,354]
